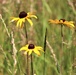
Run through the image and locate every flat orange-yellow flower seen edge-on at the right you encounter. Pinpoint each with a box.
[49,19,75,28]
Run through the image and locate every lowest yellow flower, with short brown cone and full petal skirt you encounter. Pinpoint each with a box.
[20,44,43,55]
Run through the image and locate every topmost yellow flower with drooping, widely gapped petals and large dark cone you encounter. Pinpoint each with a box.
[11,11,37,27]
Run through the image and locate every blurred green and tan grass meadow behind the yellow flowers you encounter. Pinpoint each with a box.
[0,0,76,75]
